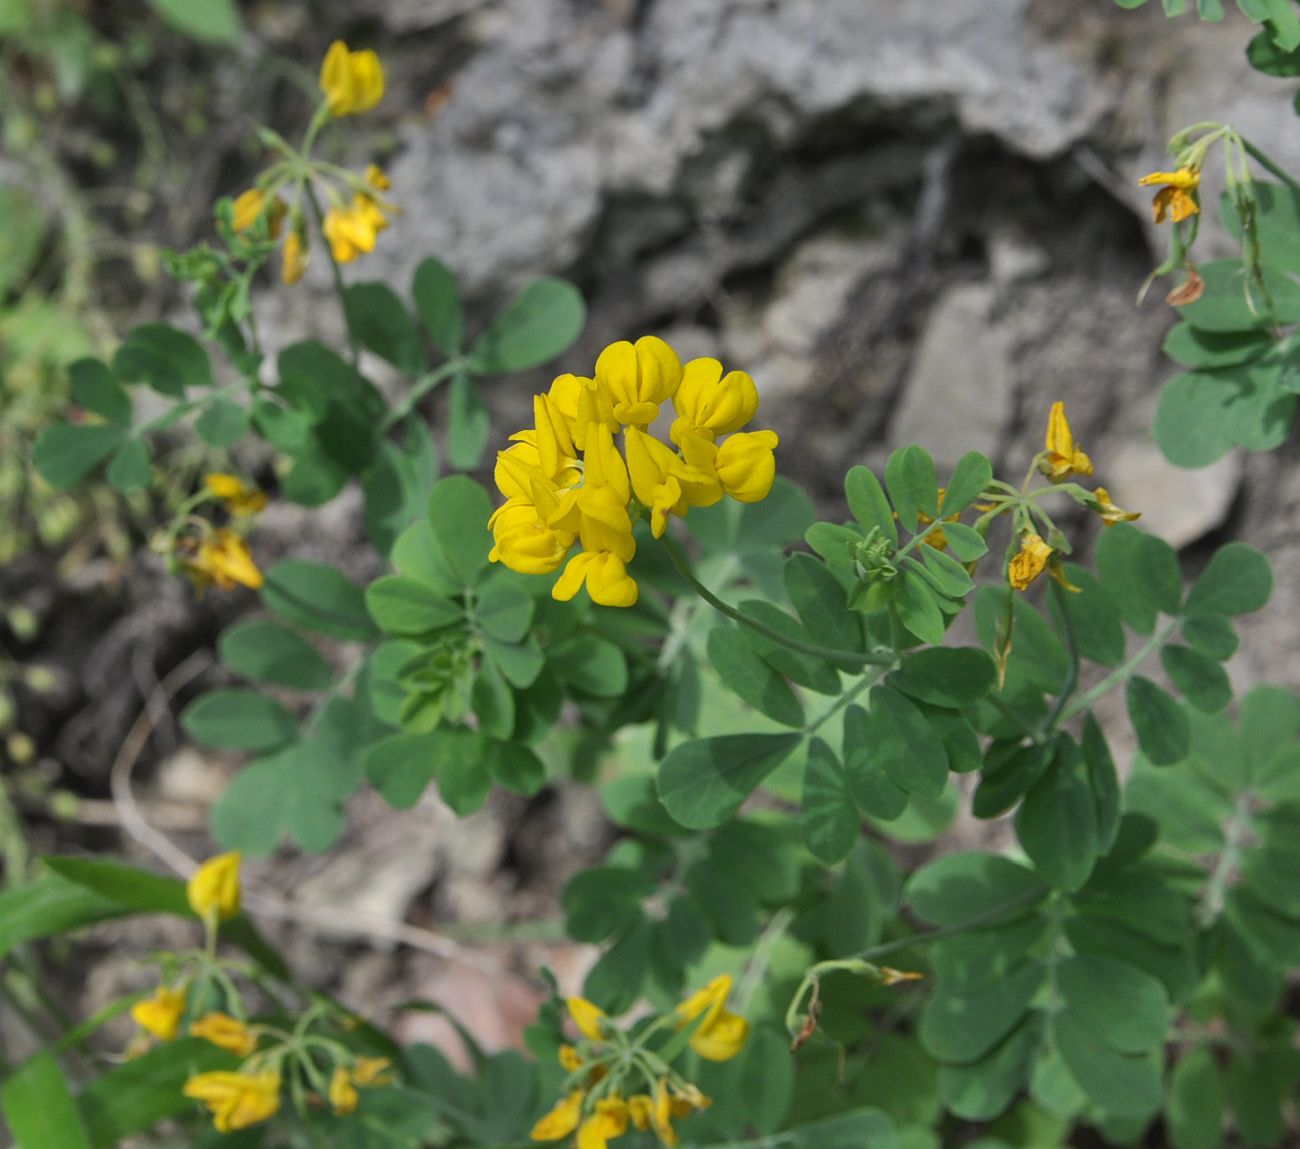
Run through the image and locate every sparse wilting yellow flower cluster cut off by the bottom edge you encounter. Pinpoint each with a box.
[530,975,749,1149]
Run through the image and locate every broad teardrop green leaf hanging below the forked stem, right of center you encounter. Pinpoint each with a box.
[1015,741,1101,890]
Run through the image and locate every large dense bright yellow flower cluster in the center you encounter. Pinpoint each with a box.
[488,335,777,607]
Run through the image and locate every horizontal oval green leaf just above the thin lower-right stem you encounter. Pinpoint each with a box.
[904,851,1048,925]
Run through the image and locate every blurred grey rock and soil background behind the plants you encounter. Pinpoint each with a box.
[0,0,1300,1059]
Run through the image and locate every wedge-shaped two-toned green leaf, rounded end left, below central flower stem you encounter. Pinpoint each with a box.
[658,734,802,829]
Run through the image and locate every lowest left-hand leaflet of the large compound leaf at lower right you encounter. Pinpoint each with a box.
[918,961,1047,1062]
